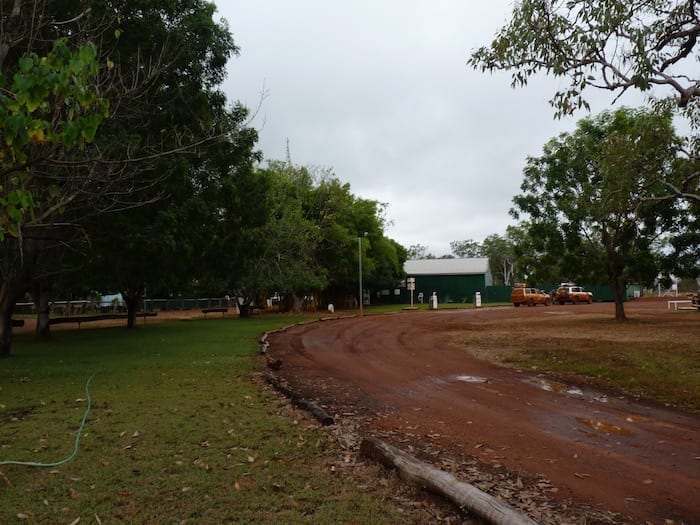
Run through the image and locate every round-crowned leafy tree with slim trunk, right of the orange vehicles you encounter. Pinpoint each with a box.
[513,108,686,320]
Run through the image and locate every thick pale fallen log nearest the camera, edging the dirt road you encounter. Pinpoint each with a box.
[360,437,537,525]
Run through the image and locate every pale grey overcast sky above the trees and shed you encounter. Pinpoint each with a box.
[216,0,641,256]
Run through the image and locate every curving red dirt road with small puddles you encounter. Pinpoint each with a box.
[269,302,700,525]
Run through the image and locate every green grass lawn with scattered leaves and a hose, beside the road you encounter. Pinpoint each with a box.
[0,316,405,524]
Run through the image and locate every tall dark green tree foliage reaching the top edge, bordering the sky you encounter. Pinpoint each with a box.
[35,0,256,320]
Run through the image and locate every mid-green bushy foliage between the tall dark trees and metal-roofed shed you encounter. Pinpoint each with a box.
[224,161,405,308]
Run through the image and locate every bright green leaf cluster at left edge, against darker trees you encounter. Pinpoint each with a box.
[0,40,109,240]
